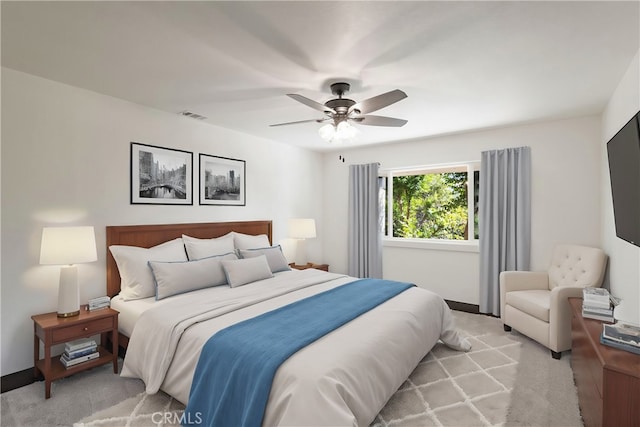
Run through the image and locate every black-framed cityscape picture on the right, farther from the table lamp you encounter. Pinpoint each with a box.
[200,154,246,206]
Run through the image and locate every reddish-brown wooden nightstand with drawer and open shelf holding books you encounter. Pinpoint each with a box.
[31,307,118,399]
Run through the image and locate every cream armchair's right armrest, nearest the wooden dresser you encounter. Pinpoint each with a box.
[549,286,584,351]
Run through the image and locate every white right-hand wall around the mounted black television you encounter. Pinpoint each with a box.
[600,51,640,324]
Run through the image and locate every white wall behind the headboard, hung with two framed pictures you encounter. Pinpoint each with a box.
[1,68,324,375]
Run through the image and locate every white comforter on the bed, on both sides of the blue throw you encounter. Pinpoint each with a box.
[122,269,470,426]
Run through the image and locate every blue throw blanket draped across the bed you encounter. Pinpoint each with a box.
[183,279,414,427]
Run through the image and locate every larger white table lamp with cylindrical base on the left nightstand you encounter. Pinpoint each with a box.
[40,227,98,317]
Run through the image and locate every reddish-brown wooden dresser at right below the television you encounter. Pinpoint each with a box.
[569,298,640,427]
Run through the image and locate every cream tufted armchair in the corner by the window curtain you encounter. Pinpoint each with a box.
[500,245,607,359]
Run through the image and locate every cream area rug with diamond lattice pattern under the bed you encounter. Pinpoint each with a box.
[74,312,582,427]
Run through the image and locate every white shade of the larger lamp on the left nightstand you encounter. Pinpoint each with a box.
[40,227,98,265]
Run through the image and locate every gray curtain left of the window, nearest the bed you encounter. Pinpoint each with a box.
[348,163,382,279]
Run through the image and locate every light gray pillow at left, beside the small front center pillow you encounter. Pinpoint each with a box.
[149,252,238,300]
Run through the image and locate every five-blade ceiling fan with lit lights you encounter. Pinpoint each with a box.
[270,82,407,141]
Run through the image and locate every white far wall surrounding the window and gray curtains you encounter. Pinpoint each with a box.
[322,116,602,304]
